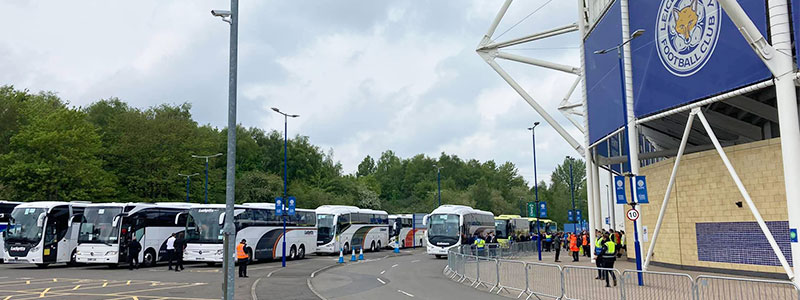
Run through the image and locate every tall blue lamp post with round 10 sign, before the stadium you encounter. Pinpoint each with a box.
[594,29,644,285]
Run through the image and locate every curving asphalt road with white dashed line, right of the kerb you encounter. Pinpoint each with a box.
[310,249,509,300]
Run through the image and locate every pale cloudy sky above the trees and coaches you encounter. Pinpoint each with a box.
[0,0,581,186]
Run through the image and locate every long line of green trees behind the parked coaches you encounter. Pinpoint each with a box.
[0,86,586,223]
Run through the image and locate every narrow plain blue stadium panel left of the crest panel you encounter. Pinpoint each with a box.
[585,1,624,143]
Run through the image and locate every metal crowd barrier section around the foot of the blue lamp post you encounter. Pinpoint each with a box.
[622,270,694,300]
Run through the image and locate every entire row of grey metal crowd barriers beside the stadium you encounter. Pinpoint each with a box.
[444,242,800,300]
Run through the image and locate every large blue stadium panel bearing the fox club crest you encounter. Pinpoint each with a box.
[632,0,771,118]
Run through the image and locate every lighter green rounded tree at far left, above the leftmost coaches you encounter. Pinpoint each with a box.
[0,104,116,201]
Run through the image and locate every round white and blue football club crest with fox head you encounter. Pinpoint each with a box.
[655,0,722,77]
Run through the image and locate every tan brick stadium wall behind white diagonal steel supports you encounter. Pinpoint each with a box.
[625,138,788,273]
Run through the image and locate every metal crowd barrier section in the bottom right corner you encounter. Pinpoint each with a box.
[694,275,800,300]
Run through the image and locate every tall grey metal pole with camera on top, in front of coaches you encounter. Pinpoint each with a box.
[206,0,239,300]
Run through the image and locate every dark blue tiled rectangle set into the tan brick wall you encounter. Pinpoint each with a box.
[695,221,792,266]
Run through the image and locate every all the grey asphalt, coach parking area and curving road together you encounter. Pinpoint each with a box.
[0,249,500,300]
